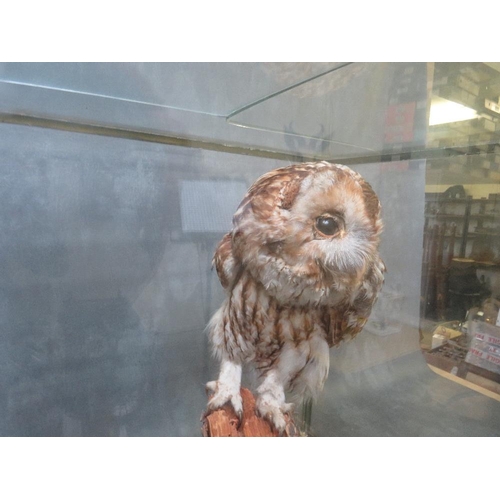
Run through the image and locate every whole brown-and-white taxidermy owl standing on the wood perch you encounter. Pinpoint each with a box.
[207,161,385,431]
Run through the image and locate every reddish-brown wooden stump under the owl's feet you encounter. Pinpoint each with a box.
[202,387,301,437]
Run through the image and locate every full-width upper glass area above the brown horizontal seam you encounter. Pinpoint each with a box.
[0,62,500,163]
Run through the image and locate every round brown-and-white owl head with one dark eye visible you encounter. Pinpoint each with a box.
[232,162,382,306]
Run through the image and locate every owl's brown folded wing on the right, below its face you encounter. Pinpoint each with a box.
[323,258,386,347]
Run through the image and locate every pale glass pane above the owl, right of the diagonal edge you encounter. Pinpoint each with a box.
[229,63,428,158]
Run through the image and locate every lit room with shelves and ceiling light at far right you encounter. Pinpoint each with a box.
[421,63,500,401]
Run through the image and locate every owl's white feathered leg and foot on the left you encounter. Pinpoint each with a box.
[206,359,243,420]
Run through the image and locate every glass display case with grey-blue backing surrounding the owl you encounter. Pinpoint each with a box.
[0,63,500,436]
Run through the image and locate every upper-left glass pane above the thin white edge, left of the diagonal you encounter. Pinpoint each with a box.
[0,62,339,116]
